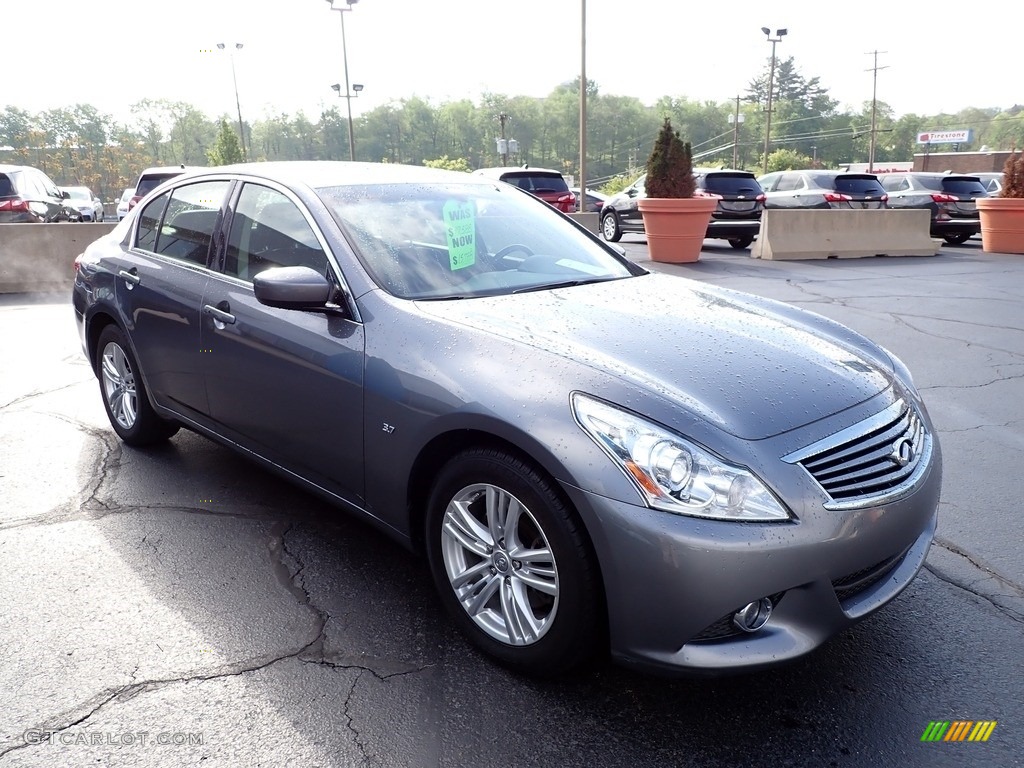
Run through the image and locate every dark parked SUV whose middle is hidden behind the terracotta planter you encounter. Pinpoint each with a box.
[601,168,765,248]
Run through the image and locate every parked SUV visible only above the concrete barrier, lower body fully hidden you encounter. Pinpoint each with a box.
[758,170,888,209]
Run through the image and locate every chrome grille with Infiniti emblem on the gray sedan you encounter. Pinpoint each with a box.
[785,400,932,508]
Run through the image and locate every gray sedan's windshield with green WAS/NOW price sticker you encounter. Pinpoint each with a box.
[317,183,644,299]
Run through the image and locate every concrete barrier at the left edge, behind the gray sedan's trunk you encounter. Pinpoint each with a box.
[0,221,117,293]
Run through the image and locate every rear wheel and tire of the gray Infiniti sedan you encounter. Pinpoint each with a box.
[95,326,180,446]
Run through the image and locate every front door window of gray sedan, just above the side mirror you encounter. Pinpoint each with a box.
[224,183,331,281]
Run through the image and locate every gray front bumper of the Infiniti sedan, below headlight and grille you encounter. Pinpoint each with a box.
[566,436,941,675]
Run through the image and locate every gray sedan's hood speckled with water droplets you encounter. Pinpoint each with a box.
[418,274,894,439]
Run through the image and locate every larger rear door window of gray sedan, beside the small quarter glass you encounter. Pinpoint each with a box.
[154,181,229,266]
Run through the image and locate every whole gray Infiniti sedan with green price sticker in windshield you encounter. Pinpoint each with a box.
[73,163,941,675]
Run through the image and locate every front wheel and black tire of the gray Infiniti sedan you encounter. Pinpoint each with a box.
[426,449,604,677]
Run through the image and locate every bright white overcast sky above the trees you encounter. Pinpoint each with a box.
[6,0,1024,131]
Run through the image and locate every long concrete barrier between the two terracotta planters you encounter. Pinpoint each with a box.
[751,208,942,259]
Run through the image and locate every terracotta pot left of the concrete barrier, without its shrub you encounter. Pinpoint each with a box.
[637,197,718,264]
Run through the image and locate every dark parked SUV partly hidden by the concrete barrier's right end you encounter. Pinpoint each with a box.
[880,171,988,246]
